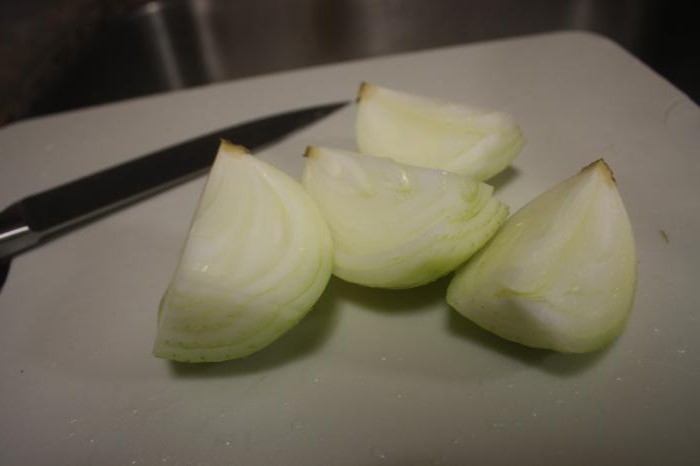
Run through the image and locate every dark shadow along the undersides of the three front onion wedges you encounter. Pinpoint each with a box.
[170,262,609,378]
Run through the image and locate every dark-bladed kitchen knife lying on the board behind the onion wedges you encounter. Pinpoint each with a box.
[0,102,349,289]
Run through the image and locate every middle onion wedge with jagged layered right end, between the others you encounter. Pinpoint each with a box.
[302,147,508,288]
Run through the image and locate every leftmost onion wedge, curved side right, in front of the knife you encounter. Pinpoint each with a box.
[153,142,333,362]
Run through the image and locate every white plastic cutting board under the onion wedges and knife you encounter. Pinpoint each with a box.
[0,33,700,466]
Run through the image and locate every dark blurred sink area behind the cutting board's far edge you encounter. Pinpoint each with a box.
[0,0,700,124]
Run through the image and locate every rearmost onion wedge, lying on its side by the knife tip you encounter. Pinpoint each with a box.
[356,83,524,180]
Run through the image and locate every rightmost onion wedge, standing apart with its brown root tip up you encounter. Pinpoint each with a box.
[447,160,636,353]
